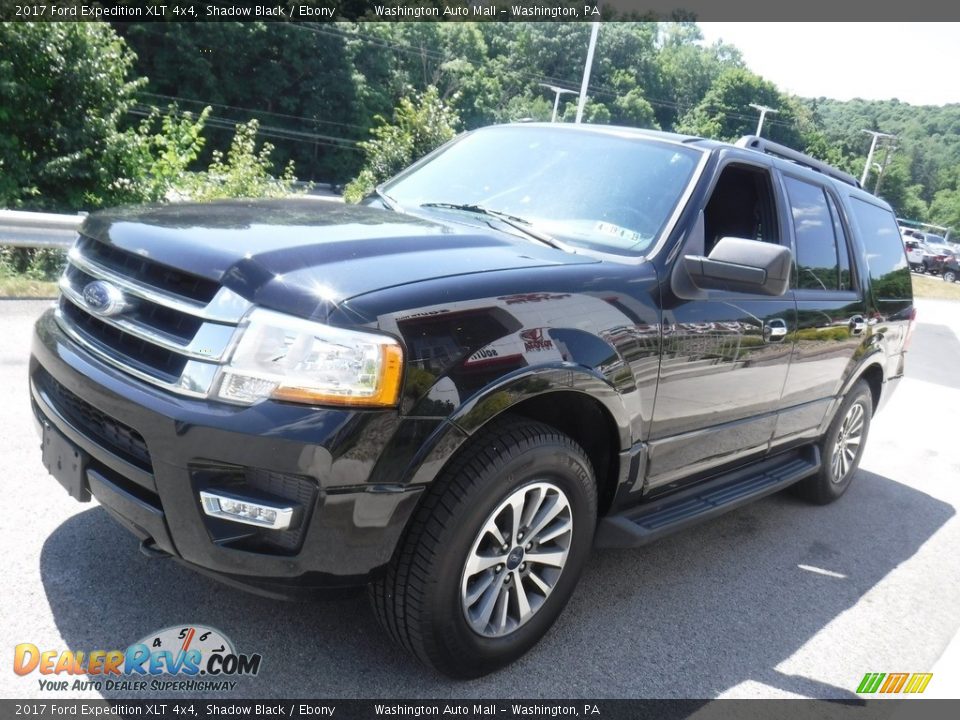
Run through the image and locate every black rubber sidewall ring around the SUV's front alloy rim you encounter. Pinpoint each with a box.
[429,440,596,676]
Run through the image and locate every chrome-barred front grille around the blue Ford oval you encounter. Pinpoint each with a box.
[57,236,250,397]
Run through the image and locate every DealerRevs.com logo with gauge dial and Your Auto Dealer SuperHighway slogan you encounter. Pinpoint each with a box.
[13,625,262,692]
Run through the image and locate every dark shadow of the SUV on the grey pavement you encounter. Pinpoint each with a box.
[40,470,954,698]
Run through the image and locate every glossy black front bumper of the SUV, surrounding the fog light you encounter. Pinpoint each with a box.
[30,311,439,597]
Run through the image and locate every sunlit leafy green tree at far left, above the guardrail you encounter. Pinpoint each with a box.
[0,23,145,211]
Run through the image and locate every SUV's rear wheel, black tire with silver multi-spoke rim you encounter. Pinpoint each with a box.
[795,380,873,505]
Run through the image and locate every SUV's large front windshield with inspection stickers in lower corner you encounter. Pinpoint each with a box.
[383,126,701,255]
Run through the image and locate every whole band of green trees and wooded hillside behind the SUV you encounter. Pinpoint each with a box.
[0,22,960,235]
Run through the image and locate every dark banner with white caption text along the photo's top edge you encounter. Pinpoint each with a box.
[0,0,960,22]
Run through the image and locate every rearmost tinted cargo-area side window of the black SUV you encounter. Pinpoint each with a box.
[850,198,913,300]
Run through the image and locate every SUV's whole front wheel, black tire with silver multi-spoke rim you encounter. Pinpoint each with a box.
[370,419,597,678]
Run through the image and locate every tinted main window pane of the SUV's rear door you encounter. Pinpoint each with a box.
[785,177,840,290]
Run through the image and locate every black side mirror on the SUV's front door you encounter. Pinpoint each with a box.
[683,237,793,296]
